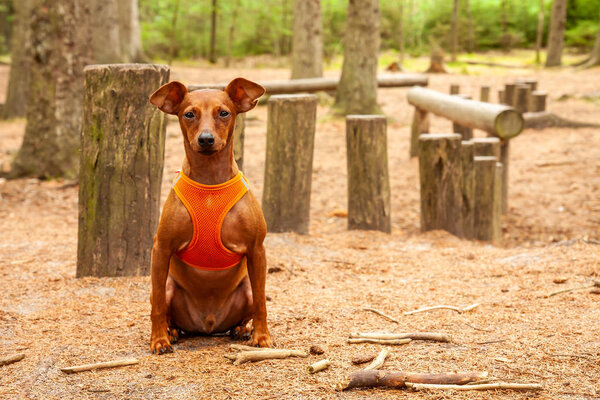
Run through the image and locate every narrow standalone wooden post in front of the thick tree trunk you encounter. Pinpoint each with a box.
[346,115,391,233]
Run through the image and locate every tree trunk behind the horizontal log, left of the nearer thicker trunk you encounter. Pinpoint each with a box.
[292,0,323,79]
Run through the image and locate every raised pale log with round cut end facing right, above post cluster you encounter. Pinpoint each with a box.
[407,87,523,139]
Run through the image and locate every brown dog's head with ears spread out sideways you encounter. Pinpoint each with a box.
[150,78,265,156]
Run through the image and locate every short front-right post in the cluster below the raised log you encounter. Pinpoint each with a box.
[474,157,500,241]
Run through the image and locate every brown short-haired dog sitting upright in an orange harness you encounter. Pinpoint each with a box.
[150,78,271,354]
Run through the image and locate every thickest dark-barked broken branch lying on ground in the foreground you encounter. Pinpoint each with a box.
[336,370,488,390]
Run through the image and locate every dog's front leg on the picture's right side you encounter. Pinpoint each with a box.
[247,243,272,347]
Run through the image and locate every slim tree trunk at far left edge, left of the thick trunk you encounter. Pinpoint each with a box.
[1,0,33,119]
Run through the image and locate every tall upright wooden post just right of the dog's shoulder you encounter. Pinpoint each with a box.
[262,94,318,234]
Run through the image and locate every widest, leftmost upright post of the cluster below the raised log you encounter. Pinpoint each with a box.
[419,133,462,236]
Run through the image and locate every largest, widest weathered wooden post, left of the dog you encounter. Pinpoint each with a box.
[77,64,169,277]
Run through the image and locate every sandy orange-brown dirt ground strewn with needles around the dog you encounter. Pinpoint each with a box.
[0,61,600,400]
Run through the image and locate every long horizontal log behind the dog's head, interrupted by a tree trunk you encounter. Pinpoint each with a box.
[188,74,429,95]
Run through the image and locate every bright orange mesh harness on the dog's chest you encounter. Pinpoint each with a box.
[173,171,249,271]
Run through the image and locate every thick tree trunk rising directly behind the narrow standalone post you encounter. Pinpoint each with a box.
[333,0,381,115]
